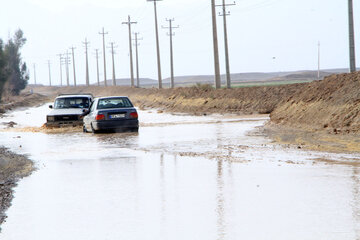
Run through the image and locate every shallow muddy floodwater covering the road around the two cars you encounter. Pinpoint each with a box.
[0,106,360,240]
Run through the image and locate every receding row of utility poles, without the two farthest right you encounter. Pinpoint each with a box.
[33,0,235,89]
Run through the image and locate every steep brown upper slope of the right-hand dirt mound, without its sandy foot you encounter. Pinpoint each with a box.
[271,73,360,134]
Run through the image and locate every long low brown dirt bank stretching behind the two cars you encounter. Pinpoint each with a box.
[34,84,302,115]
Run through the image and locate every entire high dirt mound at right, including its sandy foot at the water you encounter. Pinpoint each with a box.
[267,72,360,152]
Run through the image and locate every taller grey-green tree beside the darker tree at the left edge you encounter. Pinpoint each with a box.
[4,29,29,95]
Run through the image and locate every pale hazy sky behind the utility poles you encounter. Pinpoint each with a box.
[0,0,360,84]
